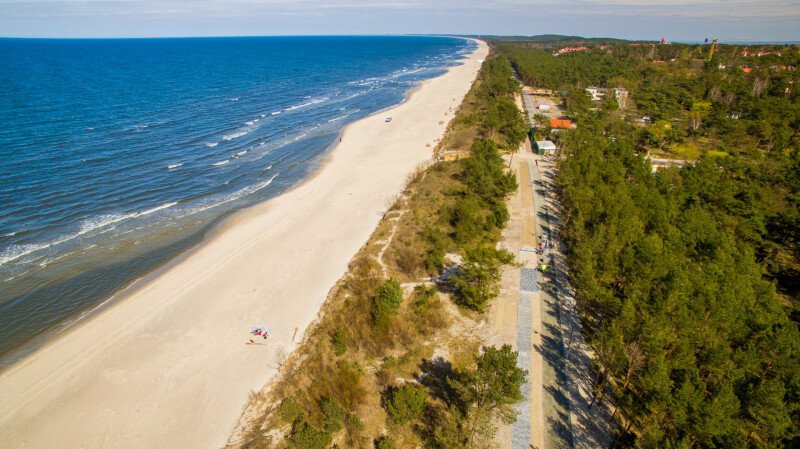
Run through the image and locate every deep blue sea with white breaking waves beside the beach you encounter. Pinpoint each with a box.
[0,37,473,356]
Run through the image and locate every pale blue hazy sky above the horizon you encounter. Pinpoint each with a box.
[0,0,800,41]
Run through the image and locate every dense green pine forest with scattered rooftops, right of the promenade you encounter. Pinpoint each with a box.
[497,39,800,448]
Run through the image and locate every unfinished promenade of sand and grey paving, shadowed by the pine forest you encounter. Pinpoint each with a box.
[511,143,610,449]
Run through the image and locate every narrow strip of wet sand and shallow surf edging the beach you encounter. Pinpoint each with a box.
[0,44,468,372]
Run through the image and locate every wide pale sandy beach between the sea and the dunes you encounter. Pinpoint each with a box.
[0,39,488,448]
